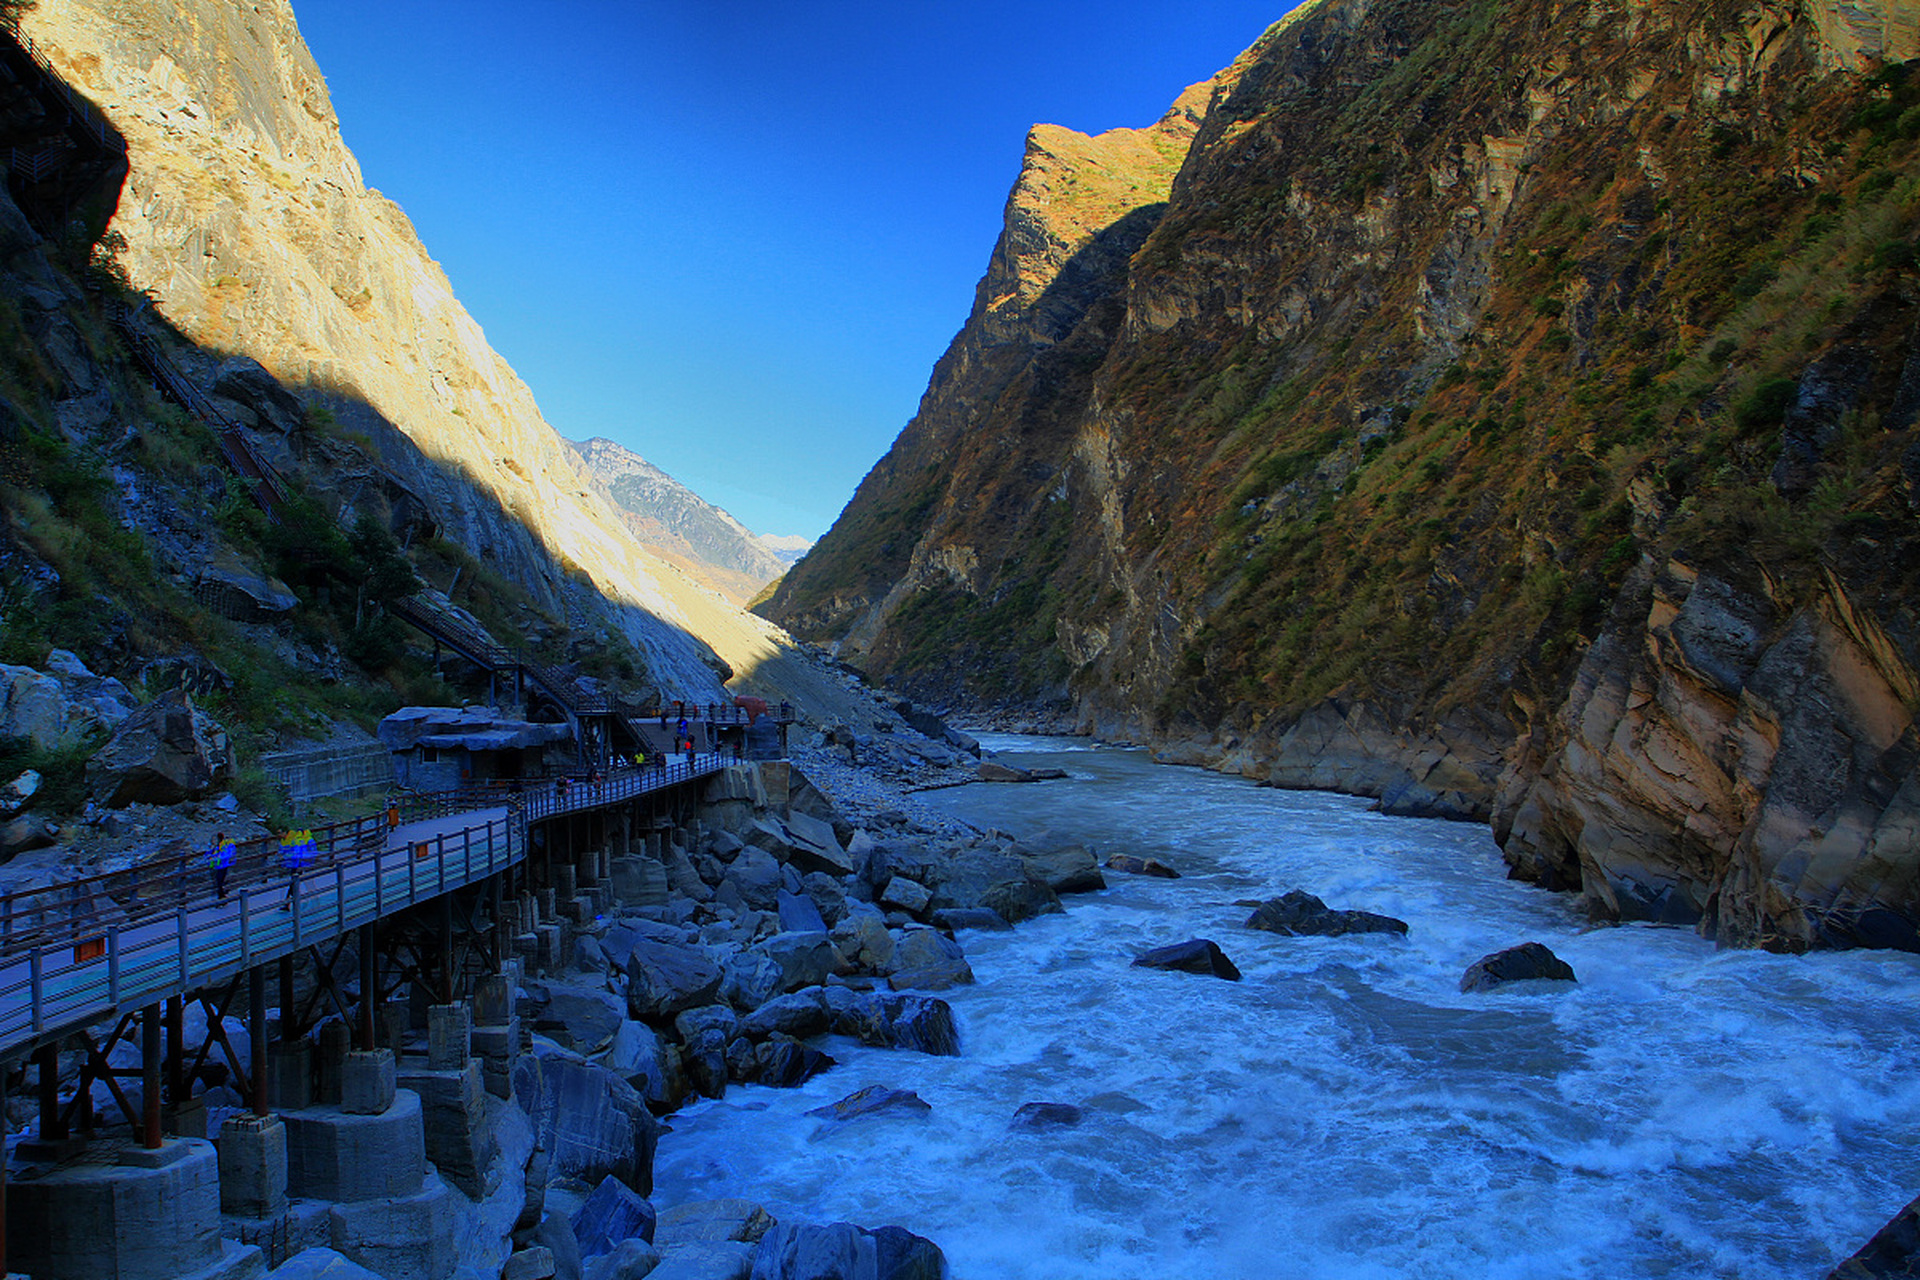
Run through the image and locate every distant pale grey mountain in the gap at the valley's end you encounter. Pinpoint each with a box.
[568,438,793,606]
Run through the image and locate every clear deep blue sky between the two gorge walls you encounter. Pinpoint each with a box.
[294,0,1288,537]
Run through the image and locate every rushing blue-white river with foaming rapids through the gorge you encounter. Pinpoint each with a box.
[655,737,1920,1280]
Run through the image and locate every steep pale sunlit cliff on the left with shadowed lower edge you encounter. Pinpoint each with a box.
[21,0,864,714]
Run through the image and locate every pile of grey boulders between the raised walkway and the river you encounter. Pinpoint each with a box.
[495,759,1104,1280]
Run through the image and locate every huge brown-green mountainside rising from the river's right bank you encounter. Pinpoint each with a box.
[758,0,1920,950]
